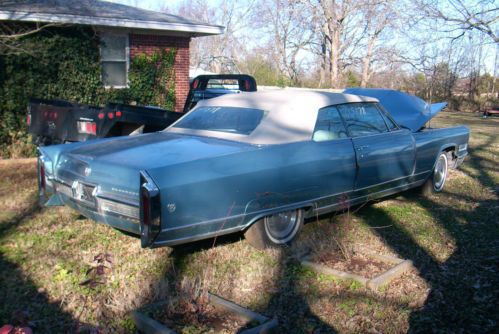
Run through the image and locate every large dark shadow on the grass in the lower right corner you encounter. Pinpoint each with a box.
[359,193,499,333]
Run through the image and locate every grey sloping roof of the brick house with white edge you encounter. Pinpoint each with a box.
[0,0,224,36]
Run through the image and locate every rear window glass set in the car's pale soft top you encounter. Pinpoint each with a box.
[174,107,264,135]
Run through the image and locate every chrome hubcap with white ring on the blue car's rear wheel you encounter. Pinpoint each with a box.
[265,210,300,244]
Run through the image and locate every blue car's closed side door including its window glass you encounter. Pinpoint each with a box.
[337,103,415,193]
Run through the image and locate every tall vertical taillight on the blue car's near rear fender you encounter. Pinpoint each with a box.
[140,171,161,247]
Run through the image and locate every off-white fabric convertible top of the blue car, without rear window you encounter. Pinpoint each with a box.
[166,89,378,145]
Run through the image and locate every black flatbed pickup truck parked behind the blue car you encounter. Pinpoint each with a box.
[27,74,257,146]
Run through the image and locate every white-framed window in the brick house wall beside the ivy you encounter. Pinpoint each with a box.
[100,34,129,88]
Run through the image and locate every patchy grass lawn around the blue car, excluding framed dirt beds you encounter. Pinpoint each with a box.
[0,112,499,333]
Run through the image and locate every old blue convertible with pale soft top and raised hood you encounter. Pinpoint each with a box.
[38,89,469,248]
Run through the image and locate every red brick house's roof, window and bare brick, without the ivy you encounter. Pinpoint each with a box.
[0,0,224,111]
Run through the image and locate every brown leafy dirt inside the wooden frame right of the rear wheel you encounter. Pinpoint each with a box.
[312,253,393,279]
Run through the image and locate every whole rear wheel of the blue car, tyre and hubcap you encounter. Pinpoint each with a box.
[244,209,303,249]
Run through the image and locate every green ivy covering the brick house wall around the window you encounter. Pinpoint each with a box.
[0,27,176,157]
